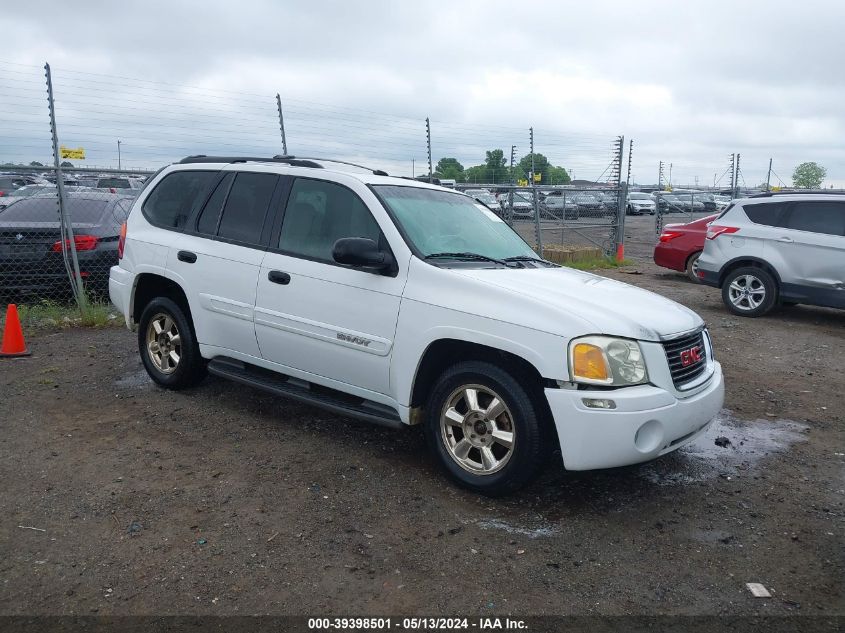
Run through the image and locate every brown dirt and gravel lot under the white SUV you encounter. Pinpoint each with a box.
[0,225,845,616]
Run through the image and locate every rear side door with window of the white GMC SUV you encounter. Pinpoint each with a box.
[167,171,281,357]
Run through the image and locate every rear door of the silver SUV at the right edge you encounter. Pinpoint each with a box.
[767,200,845,307]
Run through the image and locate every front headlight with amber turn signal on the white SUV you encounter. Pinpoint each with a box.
[569,336,648,387]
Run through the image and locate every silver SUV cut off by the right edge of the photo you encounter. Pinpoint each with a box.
[698,192,845,317]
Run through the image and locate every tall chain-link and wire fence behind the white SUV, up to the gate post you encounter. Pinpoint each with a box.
[0,62,625,314]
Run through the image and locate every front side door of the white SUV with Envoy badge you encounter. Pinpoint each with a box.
[255,178,405,394]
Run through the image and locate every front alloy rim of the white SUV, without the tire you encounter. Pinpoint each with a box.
[440,385,514,475]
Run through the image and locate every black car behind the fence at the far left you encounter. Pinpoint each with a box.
[0,192,133,298]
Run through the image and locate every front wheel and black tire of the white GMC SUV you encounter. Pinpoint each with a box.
[424,361,553,497]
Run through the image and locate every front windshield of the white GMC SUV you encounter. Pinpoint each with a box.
[374,185,537,259]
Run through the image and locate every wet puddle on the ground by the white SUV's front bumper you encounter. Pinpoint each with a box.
[640,410,807,486]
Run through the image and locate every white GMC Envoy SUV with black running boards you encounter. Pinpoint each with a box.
[109,156,724,494]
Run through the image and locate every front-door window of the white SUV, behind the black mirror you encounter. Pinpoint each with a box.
[279,178,380,262]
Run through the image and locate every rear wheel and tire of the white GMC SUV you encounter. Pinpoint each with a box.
[138,297,205,389]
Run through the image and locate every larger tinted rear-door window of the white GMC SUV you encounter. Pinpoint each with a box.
[217,173,279,244]
